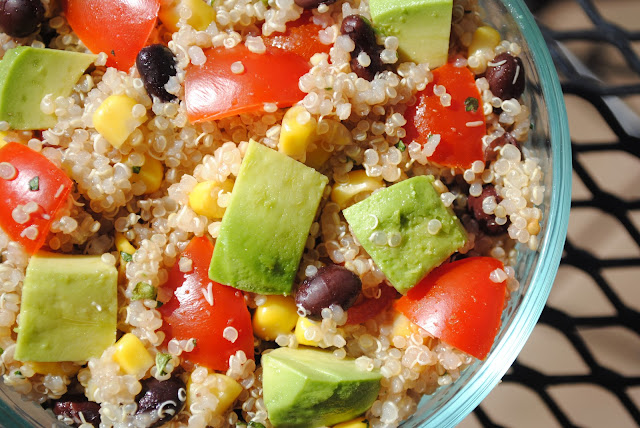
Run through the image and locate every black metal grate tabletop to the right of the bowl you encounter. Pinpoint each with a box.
[474,0,640,427]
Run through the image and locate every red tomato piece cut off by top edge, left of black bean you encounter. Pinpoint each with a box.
[63,0,160,71]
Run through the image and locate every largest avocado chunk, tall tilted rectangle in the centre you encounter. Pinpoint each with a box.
[209,141,328,294]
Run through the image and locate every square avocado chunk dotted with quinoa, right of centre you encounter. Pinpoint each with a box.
[343,175,467,294]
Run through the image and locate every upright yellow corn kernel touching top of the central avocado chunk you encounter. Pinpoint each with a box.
[278,106,318,162]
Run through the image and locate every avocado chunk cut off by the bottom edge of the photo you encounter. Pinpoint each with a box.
[262,348,382,428]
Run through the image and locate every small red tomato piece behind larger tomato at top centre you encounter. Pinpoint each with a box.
[264,12,331,61]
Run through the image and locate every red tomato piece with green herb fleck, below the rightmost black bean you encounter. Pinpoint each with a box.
[404,64,486,169]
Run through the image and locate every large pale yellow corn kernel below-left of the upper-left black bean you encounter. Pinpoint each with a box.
[93,95,147,148]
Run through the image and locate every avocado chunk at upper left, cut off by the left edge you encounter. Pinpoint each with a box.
[0,46,97,130]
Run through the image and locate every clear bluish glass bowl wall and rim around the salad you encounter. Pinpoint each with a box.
[0,0,571,428]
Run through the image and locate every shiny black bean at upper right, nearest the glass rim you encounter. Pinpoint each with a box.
[485,52,524,100]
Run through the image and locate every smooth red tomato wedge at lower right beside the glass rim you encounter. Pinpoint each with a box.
[395,257,507,359]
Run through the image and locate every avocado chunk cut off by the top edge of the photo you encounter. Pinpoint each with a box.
[369,0,453,70]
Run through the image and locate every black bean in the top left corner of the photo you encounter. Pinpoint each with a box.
[0,0,44,37]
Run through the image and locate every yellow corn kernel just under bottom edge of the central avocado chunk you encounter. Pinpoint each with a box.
[253,296,298,340]
